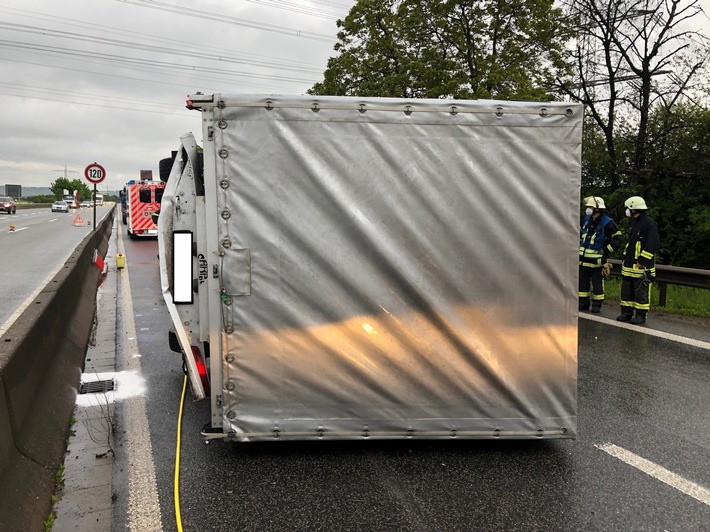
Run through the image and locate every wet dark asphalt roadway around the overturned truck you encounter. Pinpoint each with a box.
[113,235,710,531]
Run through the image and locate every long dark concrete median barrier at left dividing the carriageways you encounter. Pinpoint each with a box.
[0,207,115,531]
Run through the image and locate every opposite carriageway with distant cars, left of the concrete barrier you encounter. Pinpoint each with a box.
[0,205,111,334]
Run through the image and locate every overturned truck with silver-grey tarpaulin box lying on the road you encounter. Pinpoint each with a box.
[158,93,582,442]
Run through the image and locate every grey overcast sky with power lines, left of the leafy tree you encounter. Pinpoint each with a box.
[0,0,354,191]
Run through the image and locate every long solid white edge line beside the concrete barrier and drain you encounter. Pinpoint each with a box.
[114,219,163,532]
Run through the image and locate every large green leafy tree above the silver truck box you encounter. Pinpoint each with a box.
[309,0,569,100]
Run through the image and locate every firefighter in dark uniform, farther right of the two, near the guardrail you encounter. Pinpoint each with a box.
[616,196,660,325]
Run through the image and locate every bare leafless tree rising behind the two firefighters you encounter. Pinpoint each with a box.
[558,0,710,189]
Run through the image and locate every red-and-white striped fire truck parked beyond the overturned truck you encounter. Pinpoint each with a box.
[121,180,165,239]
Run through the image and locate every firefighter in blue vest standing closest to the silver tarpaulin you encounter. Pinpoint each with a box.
[579,196,621,314]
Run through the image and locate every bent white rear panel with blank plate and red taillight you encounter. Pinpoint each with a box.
[158,135,209,400]
